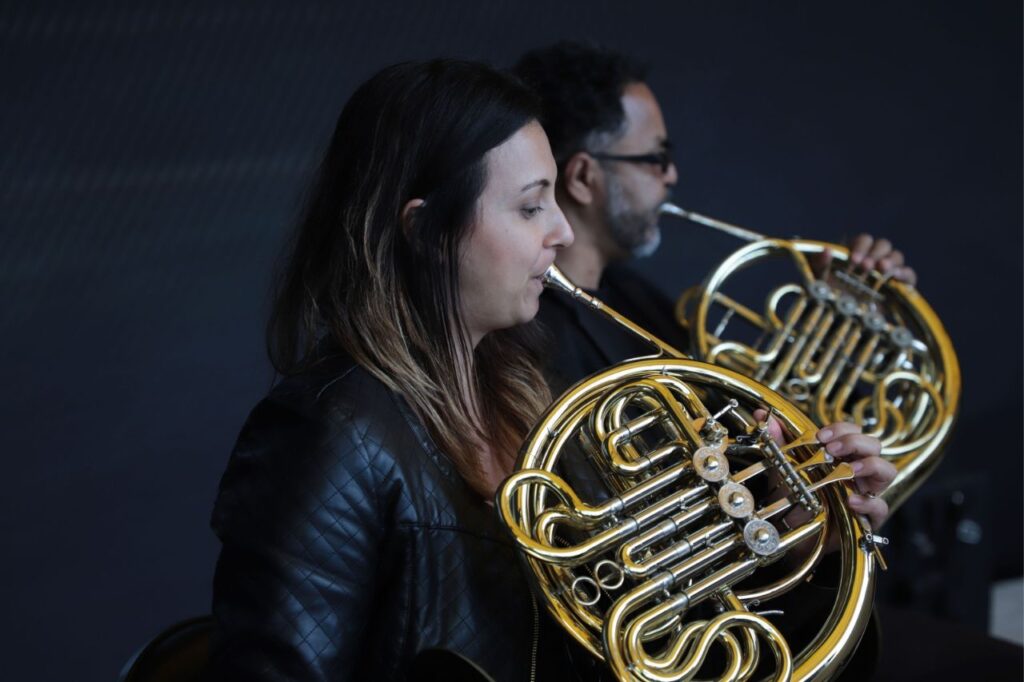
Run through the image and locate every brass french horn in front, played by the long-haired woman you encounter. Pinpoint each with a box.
[496,266,884,681]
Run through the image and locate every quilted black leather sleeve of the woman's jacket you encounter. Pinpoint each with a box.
[208,391,393,681]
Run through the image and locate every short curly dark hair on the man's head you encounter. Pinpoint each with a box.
[512,41,647,169]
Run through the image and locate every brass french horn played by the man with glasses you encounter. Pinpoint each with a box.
[660,204,961,509]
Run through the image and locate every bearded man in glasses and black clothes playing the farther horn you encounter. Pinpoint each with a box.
[513,43,915,388]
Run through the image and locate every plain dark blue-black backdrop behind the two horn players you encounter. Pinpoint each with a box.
[0,0,1022,680]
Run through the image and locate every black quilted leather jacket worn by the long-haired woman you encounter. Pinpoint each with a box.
[208,356,596,681]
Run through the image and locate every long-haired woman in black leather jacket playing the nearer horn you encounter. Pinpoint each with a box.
[211,60,897,680]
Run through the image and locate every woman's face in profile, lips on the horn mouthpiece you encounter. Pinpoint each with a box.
[459,122,572,346]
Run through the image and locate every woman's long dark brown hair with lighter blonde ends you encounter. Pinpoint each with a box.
[267,59,550,496]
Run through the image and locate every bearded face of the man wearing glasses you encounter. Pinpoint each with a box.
[601,83,678,257]
